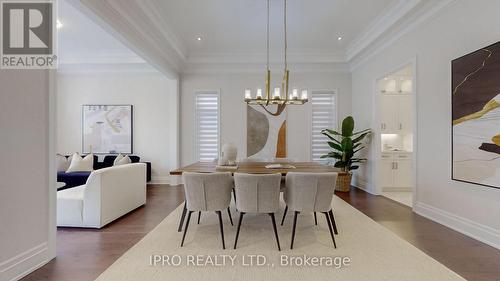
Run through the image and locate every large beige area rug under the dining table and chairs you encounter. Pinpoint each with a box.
[97,197,464,281]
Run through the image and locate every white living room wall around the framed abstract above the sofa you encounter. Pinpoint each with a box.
[57,72,178,183]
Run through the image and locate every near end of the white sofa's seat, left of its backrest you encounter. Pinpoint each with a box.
[57,185,85,226]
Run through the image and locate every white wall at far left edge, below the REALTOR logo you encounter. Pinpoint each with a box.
[0,70,55,280]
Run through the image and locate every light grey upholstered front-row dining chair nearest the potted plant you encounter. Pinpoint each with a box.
[282,172,338,249]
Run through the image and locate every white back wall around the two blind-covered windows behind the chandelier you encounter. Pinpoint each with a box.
[181,71,351,165]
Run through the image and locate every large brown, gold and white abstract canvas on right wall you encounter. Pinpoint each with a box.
[452,42,500,188]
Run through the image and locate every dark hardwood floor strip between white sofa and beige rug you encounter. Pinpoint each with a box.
[21,185,184,281]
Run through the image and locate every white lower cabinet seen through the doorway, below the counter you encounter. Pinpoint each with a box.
[380,152,413,191]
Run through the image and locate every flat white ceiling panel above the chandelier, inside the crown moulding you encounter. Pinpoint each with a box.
[152,0,394,55]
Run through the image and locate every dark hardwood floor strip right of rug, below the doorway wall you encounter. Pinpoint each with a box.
[336,188,500,281]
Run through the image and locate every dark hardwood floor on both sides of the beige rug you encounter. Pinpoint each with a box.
[22,185,500,281]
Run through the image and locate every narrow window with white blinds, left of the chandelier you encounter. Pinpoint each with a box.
[195,92,219,162]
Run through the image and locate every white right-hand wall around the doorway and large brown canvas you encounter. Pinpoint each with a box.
[352,0,500,245]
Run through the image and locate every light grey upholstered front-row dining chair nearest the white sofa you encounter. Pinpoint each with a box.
[181,172,233,249]
